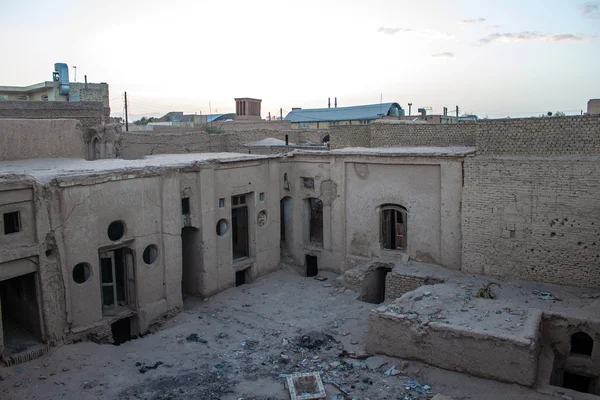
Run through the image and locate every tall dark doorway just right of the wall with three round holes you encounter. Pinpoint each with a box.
[181,226,202,294]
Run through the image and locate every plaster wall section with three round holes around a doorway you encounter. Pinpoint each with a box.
[61,173,182,327]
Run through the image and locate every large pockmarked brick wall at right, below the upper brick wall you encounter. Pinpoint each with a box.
[462,158,600,288]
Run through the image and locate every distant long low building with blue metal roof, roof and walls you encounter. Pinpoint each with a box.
[285,103,404,129]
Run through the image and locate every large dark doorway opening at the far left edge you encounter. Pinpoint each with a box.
[0,272,42,358]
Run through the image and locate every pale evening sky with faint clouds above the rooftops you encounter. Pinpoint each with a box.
[0,0,600,119]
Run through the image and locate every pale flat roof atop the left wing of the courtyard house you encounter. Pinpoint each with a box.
[0,153,279,183]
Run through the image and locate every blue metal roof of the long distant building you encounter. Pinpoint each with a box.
[285,103,401,122]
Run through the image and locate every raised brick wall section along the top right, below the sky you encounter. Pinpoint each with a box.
[474,116,600,157]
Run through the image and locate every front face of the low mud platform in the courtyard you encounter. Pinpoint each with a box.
[367,307,541,387]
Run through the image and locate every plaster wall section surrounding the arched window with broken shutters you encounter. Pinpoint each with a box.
[339,159,461,268]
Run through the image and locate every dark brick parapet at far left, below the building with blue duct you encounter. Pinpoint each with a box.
[0,101,110,129]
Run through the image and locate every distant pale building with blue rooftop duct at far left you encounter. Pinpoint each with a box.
[0,63,110,108]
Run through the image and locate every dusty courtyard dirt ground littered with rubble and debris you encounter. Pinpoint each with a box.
[0,267,556,400]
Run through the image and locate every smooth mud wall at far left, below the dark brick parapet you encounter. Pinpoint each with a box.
[0,119,87,161]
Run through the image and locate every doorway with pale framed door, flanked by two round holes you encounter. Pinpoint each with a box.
[99,247,137,315]
